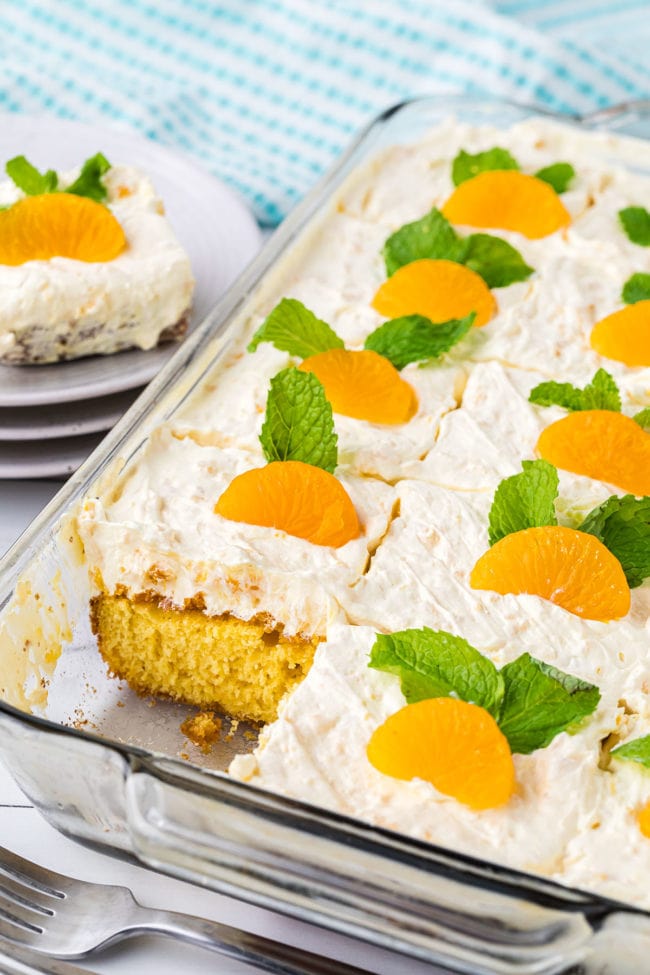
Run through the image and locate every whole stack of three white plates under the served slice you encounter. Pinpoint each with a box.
[0,115,261,478]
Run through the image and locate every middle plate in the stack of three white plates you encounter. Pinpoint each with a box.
[0,389,140,440]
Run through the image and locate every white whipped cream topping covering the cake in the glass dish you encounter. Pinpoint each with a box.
[79,120,650,906]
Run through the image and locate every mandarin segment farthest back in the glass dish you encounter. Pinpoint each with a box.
[442,169,571,240]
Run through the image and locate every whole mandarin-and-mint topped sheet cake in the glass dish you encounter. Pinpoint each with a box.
[79,120,650,907]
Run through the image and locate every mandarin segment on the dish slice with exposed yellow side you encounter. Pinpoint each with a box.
[214,460,361,548]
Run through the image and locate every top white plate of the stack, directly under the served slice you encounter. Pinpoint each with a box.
[0,114,261,406]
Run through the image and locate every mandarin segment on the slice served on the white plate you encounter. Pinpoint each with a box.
[0,193,126,265]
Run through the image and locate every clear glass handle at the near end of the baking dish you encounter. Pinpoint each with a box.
[121,772,650,975]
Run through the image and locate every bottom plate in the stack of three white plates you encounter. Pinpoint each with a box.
[0,433,103,480]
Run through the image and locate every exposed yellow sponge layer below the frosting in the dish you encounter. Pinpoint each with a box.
[91,594,320,722]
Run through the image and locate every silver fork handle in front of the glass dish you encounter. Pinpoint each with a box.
[132,905,368,975]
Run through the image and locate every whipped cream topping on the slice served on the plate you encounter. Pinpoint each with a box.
[0,165,194,358]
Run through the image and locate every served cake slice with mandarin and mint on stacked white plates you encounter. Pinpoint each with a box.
[0,153,194,365]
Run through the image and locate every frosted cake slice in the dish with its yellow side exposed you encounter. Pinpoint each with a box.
[79,380,396,721]
